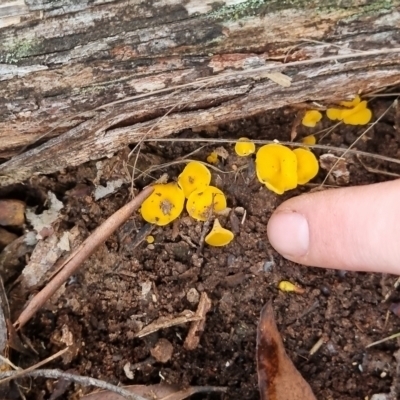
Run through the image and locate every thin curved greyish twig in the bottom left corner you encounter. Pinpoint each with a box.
[0,369,148,400]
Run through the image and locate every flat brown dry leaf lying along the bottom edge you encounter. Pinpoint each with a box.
[83,383,226,400]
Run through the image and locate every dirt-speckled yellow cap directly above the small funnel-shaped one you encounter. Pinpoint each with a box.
[186,186,226,221]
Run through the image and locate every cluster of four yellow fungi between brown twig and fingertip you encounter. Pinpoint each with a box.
[141,161,234,246]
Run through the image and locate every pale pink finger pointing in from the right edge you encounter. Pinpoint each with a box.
[267,179,400,275]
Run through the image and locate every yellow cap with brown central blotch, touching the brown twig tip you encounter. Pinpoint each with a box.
[140,182,185,226]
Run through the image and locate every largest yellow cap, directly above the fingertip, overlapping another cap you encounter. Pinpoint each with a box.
[256,144,297,194]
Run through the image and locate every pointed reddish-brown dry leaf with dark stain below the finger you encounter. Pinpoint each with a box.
[257,302,316,400]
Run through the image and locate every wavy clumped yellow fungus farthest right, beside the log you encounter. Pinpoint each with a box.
[326,96,372,125]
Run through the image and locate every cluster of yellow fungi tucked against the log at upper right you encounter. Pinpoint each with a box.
[301,95,372,128]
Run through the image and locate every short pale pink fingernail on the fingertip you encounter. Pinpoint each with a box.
[267,211,310,257]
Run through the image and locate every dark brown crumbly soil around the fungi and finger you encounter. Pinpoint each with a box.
[2,94,400,400]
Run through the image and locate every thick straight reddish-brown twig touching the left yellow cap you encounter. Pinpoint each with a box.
[14,186,154,329]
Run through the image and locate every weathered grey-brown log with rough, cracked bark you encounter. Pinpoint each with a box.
[0,0,400,186]
